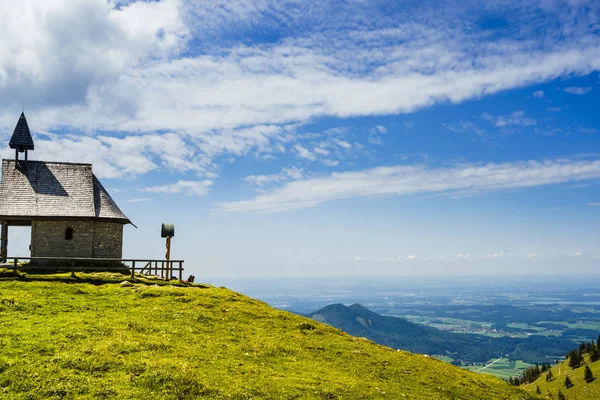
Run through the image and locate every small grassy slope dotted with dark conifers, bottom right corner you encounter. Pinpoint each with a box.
[522,358,600,400]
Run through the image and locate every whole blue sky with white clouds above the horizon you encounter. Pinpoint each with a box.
[0,0,600,277]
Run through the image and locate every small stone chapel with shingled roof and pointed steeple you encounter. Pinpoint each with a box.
[0,114,131,264]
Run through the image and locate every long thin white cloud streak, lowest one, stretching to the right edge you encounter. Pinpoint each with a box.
[217,159,600,212]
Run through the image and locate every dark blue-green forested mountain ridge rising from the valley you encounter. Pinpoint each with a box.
[307,304,573,363]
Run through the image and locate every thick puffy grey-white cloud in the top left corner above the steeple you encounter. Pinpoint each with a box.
[0,0,188,108]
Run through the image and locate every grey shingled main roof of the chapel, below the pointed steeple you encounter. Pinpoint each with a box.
[0,160,131,224]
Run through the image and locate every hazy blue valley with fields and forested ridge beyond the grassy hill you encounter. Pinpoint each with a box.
[218,276,600,379]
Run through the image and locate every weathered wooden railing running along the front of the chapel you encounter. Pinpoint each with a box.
[6,257,183,281]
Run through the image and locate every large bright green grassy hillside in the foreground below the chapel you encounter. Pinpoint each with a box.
[0,275,536,399]
